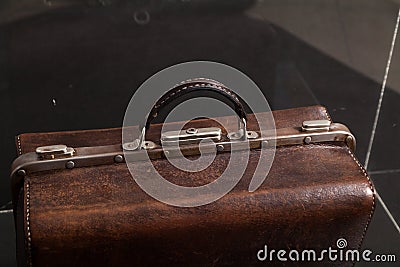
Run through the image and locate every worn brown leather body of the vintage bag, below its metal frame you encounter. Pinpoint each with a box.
[13,106,374,266]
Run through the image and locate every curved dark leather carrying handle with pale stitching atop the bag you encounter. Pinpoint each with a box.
[145,78,247,130]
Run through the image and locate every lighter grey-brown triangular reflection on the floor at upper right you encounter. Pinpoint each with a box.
[247,0,400,92]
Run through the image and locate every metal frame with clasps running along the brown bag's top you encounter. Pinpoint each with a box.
[11,120,356,201]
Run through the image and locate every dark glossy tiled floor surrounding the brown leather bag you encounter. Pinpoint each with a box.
[0,0,400,266]
